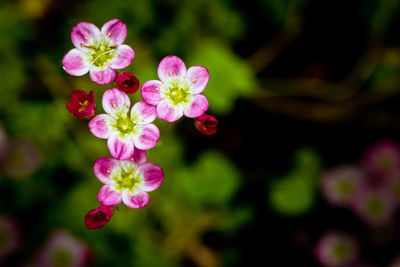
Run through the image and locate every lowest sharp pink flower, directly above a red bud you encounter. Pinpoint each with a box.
[93,149,164,209]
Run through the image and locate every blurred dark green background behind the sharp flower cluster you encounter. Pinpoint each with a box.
[0,0,400,267]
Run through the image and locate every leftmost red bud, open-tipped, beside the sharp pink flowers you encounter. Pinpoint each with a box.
[67,90,97,119]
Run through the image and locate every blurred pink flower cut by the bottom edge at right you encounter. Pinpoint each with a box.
[314,232,358,267]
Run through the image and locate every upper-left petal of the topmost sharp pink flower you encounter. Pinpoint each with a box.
[71,22,100,50]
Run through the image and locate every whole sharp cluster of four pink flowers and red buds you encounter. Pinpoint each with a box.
[62,19,218,229]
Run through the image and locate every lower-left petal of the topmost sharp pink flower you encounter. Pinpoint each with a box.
[62,48,90,76]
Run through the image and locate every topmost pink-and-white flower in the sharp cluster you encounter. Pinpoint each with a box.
[62,19,135,84]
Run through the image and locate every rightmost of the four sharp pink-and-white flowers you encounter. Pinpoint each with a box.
[141,56,210,122]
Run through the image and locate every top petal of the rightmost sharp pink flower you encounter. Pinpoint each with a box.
[157,56,186,81]
